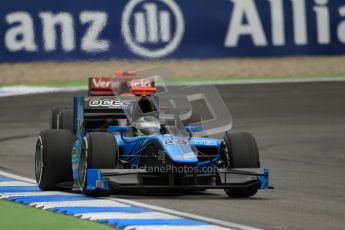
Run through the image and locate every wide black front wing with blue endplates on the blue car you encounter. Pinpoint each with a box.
[86,168,272,191]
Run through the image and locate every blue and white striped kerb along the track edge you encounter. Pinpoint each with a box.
[0,171,257,230]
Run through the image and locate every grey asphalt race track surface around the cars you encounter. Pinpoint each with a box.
[0,82,345,230]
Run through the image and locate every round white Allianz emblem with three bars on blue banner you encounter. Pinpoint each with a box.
[122,0,185,58]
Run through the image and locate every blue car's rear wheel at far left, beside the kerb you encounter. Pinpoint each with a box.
[35,129,74,191]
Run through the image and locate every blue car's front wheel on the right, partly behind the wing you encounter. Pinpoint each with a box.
[223,132,260,197]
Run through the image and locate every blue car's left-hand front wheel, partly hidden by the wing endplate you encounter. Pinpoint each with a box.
[78,132,118,196]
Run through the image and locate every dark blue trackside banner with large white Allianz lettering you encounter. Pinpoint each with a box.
[0,0,345,62]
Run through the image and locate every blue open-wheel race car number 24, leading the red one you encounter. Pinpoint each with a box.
[35,68,271,197]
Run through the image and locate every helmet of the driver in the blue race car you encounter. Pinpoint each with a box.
[133,116,161,136]
